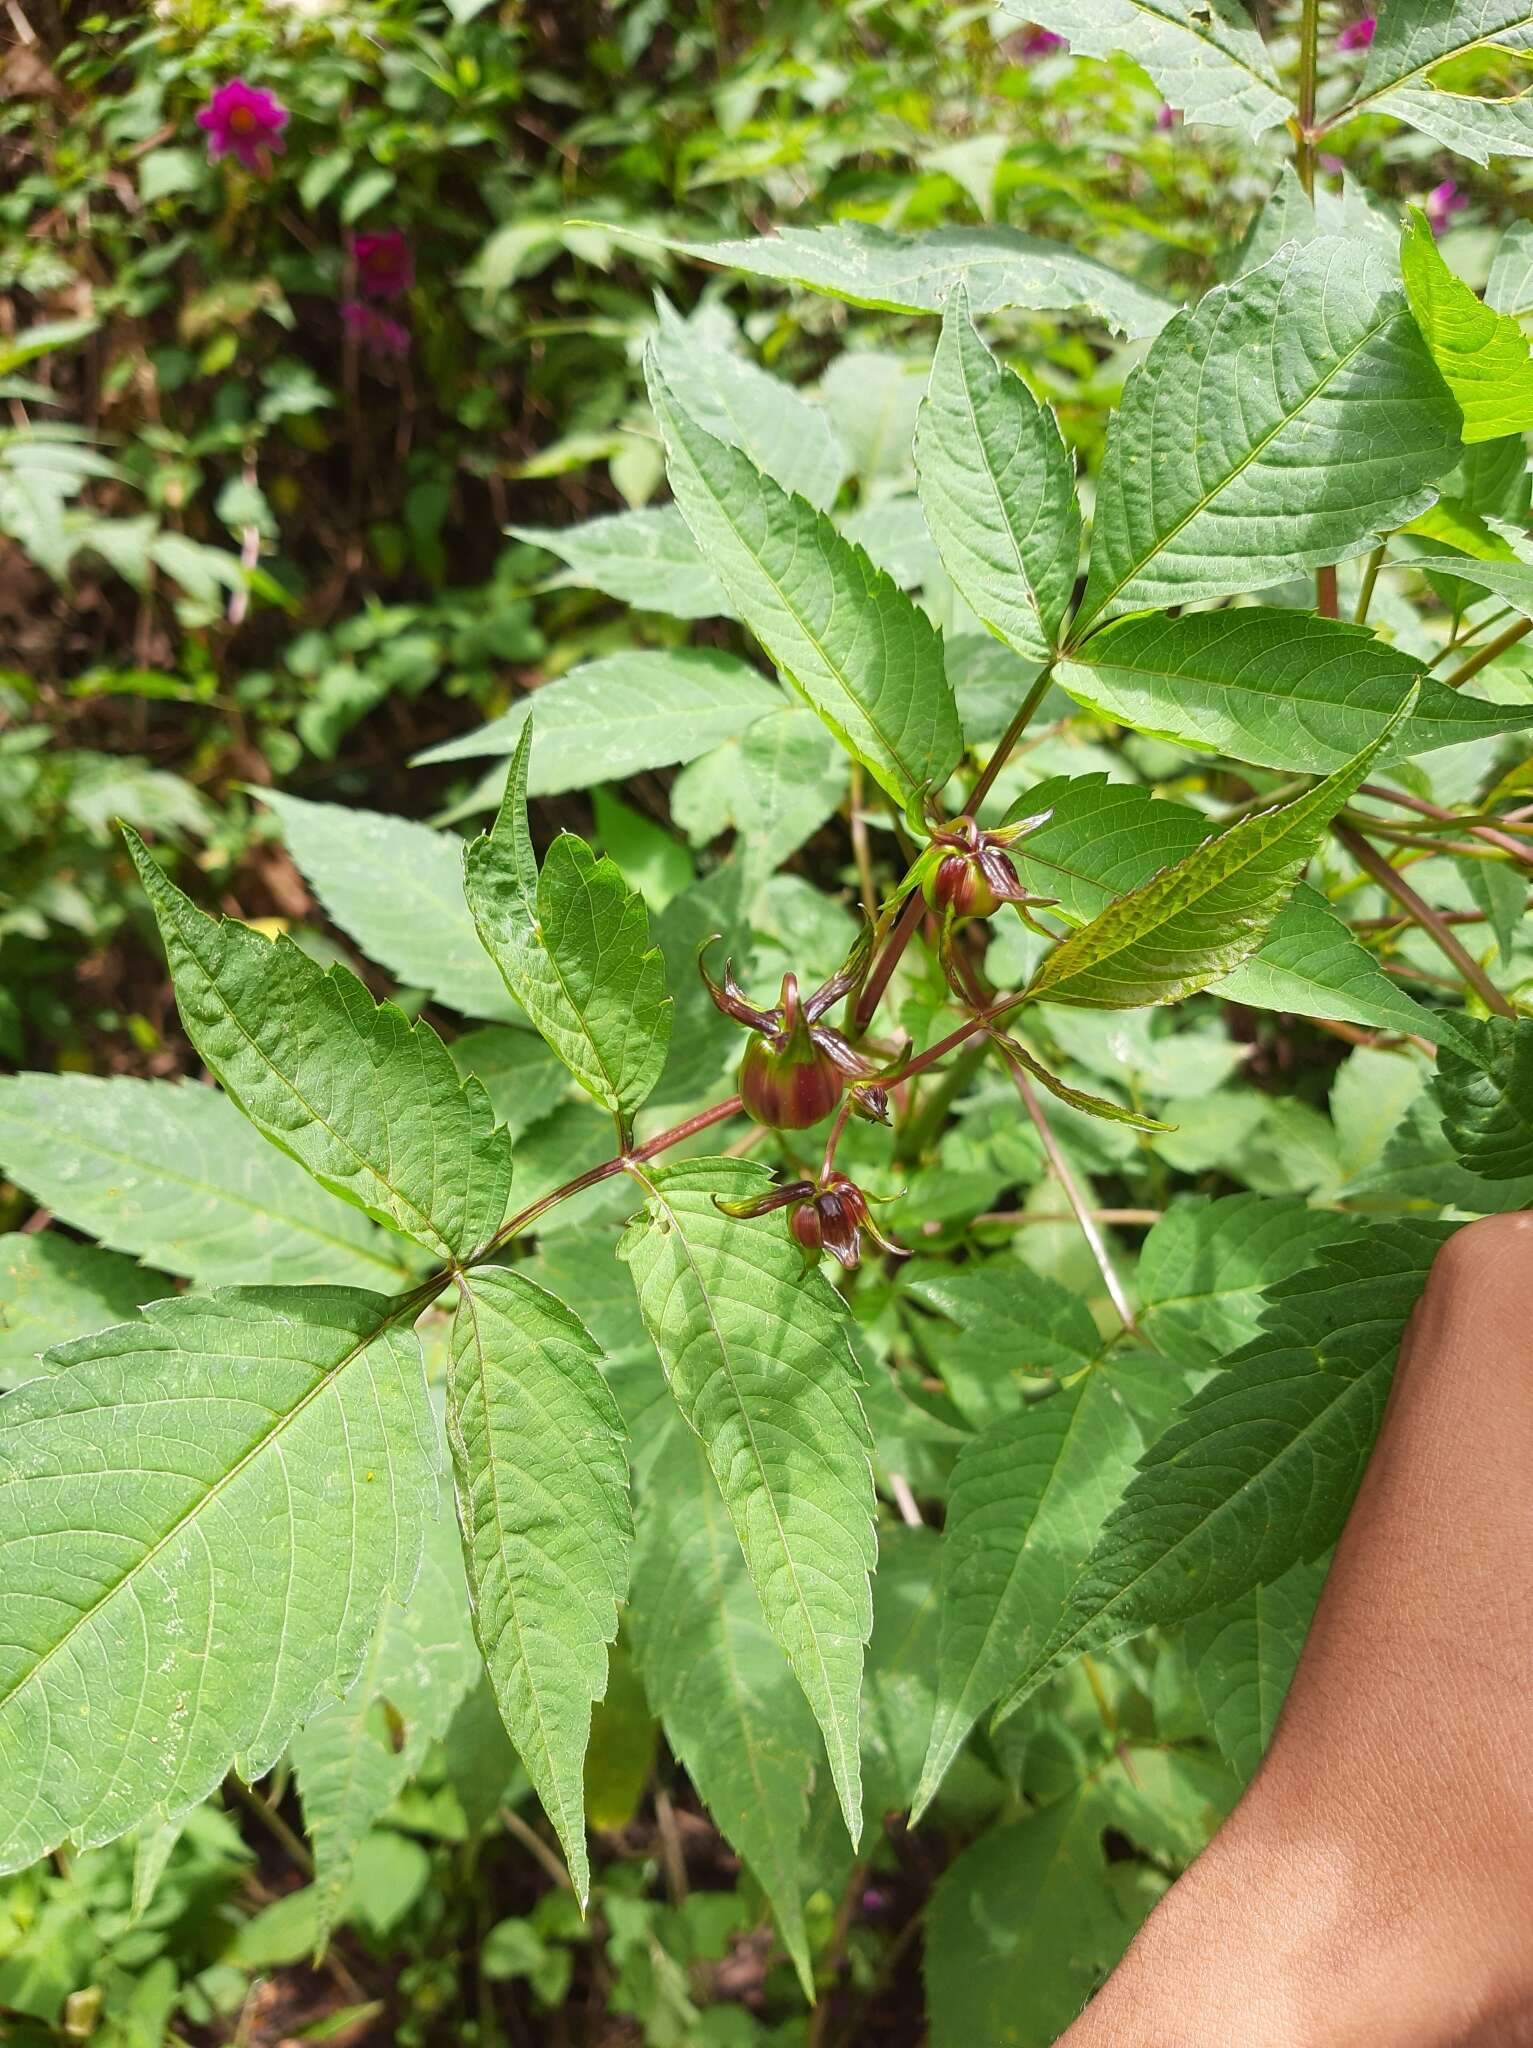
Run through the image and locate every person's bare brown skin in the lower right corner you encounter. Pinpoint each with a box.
[1058,1214,1533,2048]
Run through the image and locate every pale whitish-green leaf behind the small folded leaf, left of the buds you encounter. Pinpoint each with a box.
[260,788,526,1022]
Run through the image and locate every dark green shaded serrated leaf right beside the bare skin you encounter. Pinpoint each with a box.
[997,1219,1449,1720]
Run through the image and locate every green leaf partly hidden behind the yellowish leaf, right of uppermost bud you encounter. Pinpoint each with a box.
[1009,776,1445,1038]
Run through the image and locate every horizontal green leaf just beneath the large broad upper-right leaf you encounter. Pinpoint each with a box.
[1054,606,1533,774]
